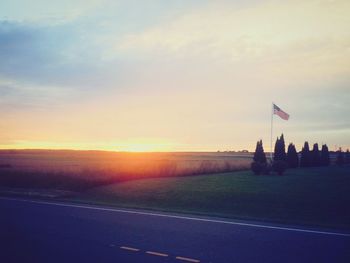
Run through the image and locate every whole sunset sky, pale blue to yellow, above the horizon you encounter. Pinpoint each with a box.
[0,0,350,151]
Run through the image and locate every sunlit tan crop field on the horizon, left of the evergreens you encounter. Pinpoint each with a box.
[0,150,252,191]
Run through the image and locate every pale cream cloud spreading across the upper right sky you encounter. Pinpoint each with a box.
[114,1,350,80]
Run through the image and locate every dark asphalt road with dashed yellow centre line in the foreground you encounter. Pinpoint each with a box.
[0,198,350,263]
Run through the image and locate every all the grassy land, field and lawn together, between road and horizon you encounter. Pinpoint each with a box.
[0,150,350,230]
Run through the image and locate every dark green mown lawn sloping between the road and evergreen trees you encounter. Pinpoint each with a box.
[75,166,350,230]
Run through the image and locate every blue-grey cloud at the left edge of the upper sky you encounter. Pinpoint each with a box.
[0,21,124,92]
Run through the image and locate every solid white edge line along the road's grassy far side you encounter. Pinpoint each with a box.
[0,197,350,237]
